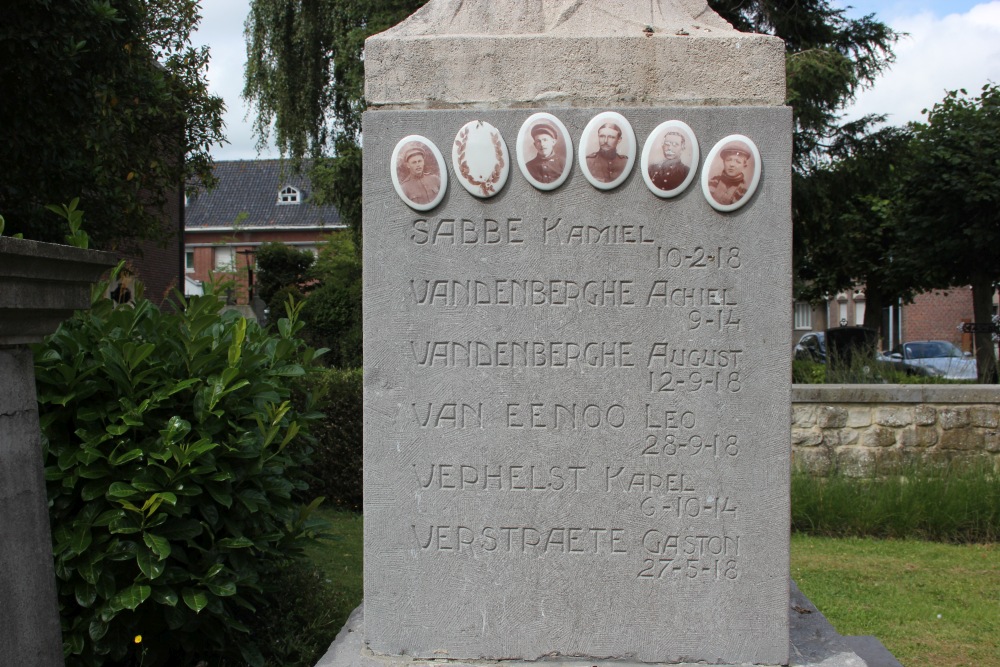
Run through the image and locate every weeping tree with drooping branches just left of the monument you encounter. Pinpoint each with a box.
[243,0,426,249]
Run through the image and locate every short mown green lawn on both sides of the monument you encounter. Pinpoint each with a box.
[309,510,1000,667]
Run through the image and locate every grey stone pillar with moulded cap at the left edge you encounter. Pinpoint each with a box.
[0,237,117,666]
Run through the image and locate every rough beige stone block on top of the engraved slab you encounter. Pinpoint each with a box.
[365,0,785,108]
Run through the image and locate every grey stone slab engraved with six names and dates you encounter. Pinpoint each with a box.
[365,110,791,662]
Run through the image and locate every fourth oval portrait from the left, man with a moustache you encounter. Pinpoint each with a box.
[579,111,638,190]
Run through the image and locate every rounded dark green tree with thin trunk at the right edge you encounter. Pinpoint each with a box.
[899,84,1000,383]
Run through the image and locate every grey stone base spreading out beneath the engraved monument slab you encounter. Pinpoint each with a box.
[316,581,902,667]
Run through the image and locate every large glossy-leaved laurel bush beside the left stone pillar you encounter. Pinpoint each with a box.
[35,294,323,666]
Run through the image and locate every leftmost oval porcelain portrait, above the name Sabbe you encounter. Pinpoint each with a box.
[389,134,448,211]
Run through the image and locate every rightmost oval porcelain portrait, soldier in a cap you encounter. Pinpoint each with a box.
[701,134,763,212]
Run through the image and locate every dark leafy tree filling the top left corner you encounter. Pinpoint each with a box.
[0,0,224,249]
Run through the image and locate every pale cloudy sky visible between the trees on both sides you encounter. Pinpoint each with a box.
[195,0,1000,160]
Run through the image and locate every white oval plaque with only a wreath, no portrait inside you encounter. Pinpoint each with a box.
[451,120,510,198]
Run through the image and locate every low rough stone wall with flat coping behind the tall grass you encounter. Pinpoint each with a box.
[792,385,1000,474]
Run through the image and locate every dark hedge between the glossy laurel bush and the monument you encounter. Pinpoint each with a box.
[300,368,364,511]
